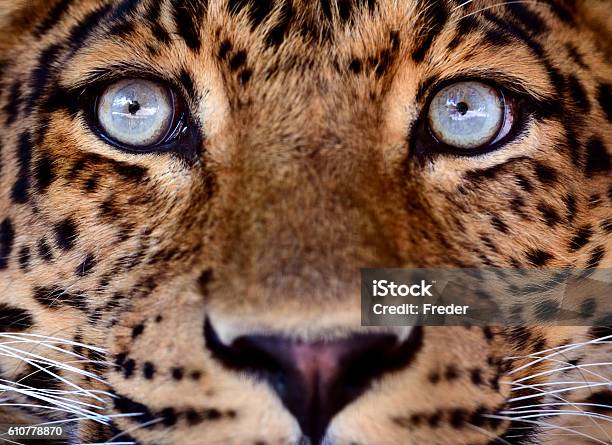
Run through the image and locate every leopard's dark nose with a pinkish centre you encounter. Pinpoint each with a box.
[205,323,422,444]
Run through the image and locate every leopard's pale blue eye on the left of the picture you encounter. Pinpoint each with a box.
[95,79,179,150]
